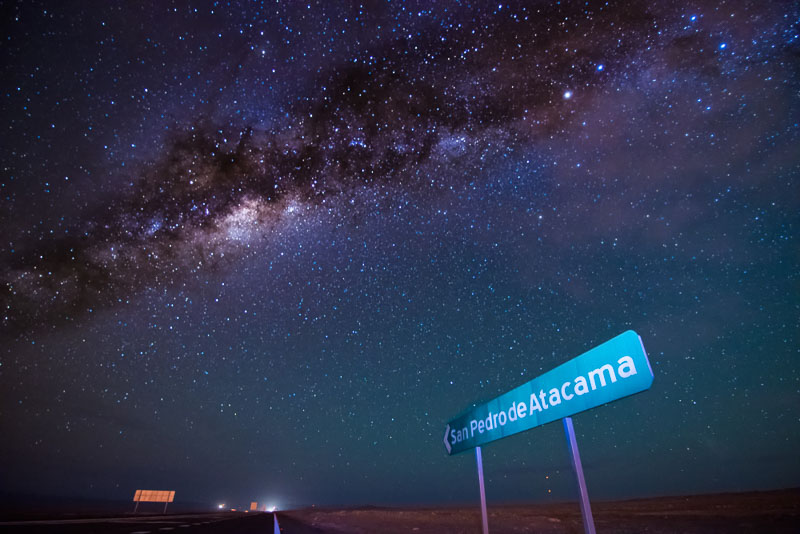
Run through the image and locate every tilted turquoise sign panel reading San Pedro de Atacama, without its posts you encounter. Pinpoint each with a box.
[444,330,653,455]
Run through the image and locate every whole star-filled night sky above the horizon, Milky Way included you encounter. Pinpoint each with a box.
[0,0,800,508]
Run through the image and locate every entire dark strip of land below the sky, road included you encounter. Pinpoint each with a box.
[0,488,800,534]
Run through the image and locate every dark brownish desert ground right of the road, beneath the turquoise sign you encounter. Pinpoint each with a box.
[279,489,800,534]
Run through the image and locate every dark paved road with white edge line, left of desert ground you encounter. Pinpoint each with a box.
[0,513,282,534]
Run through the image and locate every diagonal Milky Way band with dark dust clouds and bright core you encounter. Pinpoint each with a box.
[0,1,788,335]
